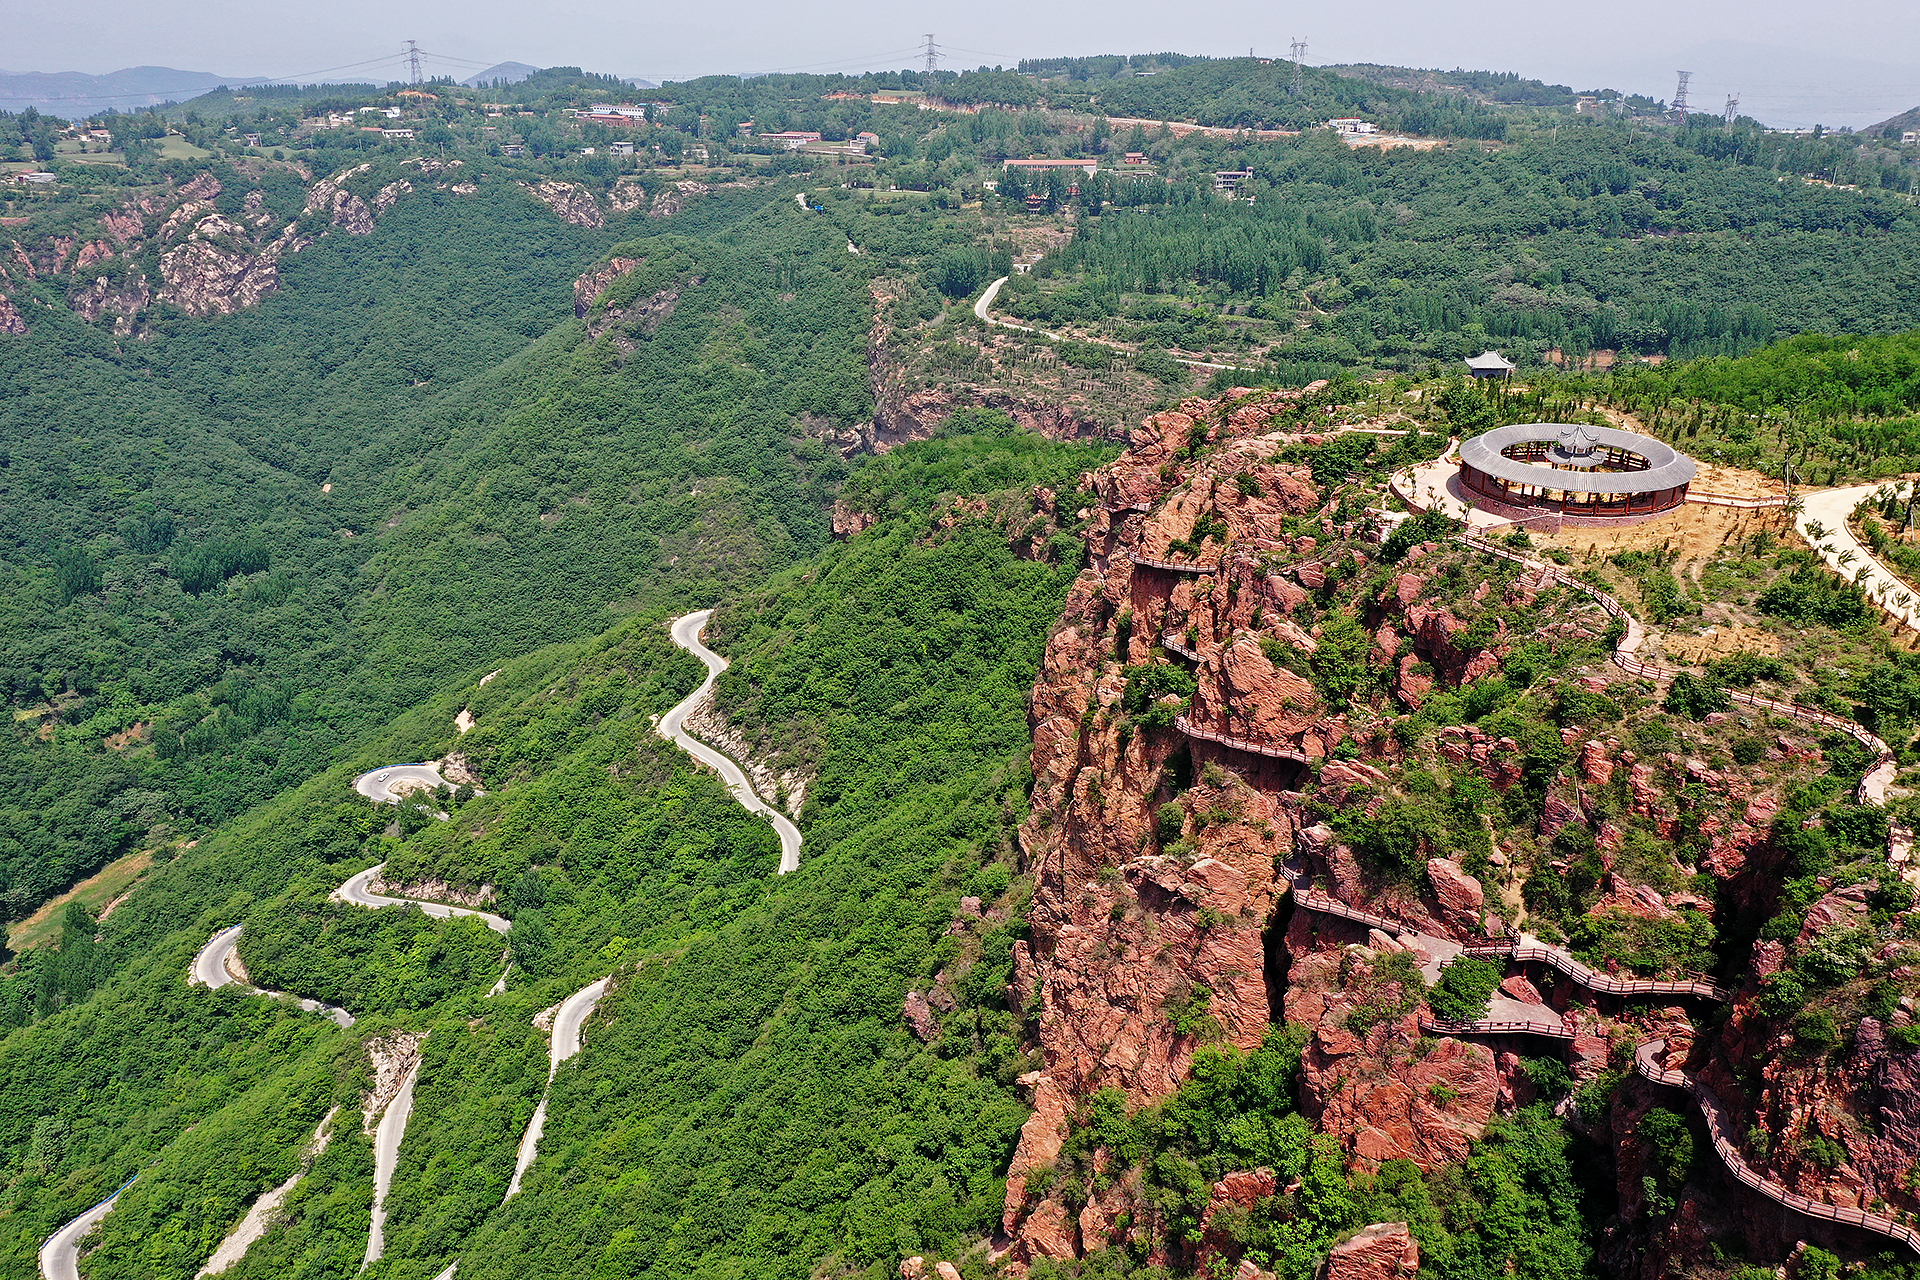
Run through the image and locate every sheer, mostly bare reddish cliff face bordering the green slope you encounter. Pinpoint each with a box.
[1004,385,1566,1257]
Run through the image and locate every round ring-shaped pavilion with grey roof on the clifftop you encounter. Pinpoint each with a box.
[1459,422,1699,524]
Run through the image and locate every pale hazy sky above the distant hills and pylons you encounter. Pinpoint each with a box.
[15,0,1920,123]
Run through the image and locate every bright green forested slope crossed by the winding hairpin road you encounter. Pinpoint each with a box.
[0,422,1100,1278]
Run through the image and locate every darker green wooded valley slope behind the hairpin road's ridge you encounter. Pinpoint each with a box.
[0,172,868,932]
